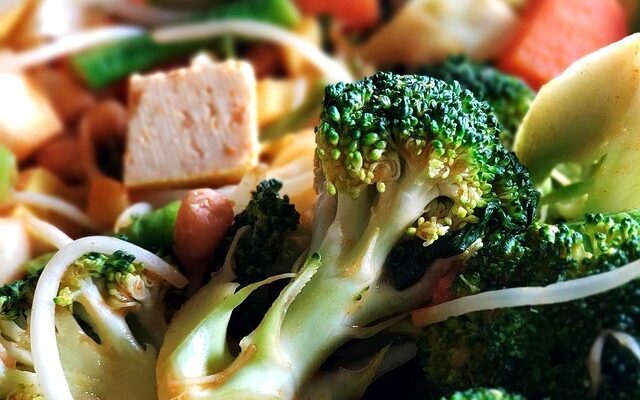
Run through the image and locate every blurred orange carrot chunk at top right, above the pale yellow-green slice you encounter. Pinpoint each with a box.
[498,0,627,88]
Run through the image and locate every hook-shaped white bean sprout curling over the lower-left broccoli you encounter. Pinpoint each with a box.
[31,236,187,400]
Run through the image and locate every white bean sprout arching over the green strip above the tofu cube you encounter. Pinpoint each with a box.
[151,19,353,82]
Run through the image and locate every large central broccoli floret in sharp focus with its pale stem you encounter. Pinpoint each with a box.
[158,73,537,400]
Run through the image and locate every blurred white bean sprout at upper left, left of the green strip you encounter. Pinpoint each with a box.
[0,26,144,72]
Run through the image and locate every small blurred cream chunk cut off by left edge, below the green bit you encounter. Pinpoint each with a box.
[0,217,31,285]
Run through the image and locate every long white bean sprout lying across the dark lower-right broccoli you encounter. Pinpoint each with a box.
[412,260,640,326]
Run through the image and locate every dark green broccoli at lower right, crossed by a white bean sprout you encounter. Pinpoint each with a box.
[419,211,640,400]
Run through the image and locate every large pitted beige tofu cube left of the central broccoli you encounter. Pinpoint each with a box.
[124,58,259,188]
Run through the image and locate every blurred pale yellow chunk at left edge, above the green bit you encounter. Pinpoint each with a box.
[0,72,62,160]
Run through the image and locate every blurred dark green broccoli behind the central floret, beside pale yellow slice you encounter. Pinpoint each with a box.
[420,56,535,148]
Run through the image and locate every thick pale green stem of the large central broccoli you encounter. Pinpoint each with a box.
[205,173,440,399]
